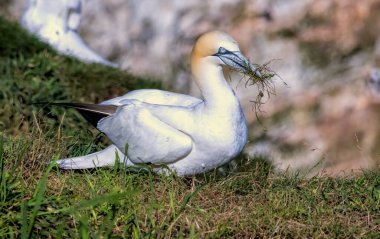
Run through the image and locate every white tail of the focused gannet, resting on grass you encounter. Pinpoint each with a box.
[57,145,133,169]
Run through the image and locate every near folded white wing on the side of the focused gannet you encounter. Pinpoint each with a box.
[98,100,192,165]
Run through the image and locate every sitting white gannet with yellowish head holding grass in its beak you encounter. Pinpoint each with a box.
[58,31,260,176]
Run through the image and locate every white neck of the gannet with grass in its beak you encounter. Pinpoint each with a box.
[192,58,239,109]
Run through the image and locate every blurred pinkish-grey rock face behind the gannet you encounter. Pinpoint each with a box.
[2,0,380,175]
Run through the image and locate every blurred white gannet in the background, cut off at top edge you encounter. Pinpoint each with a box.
[21,0,117,67]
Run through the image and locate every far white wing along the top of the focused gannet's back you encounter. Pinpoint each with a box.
[101,89,202,106]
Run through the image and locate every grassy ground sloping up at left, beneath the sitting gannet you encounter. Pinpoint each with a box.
[0,18,380,238]
